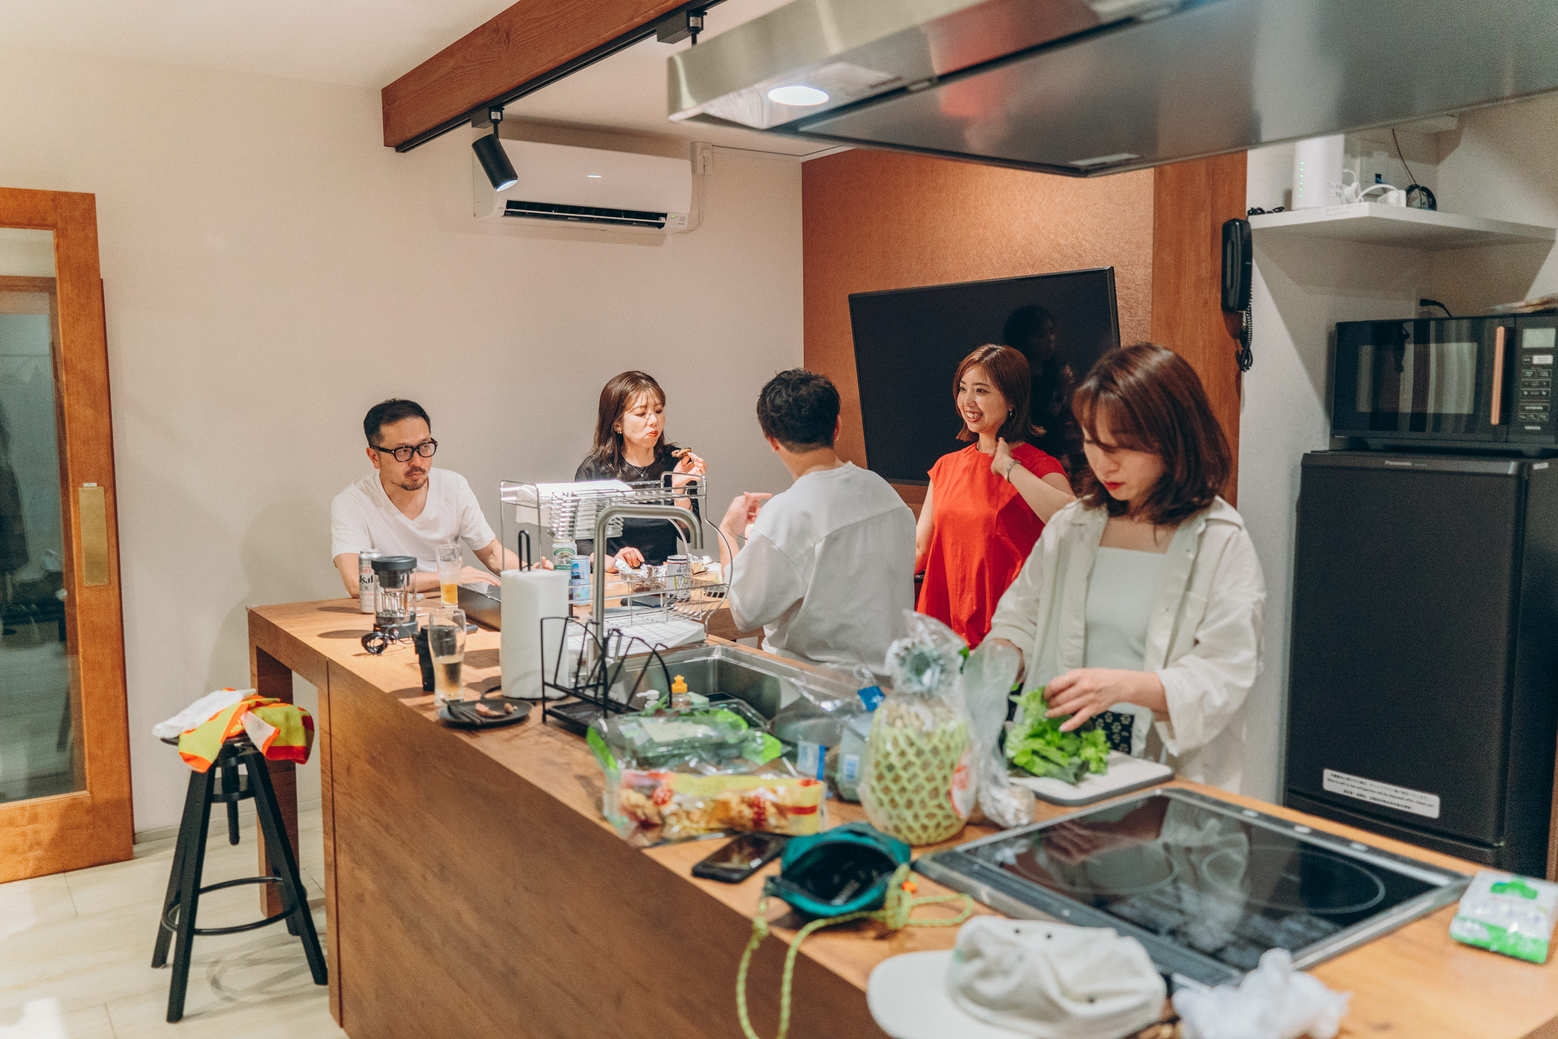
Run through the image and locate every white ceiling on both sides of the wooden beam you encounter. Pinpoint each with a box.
[0,0,824,154]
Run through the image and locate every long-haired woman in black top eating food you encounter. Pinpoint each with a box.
[573,371,707,570]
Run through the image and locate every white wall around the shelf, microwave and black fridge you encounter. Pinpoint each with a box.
[1239,98,1558,801]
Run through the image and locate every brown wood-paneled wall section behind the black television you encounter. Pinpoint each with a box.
[801,150,1245,497]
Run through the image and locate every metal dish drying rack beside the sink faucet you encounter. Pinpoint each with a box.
[499,474,729,732]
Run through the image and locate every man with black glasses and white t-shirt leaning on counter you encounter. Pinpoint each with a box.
[330,400,519,597]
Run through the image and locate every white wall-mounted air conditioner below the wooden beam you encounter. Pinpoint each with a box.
[471,140,693,232]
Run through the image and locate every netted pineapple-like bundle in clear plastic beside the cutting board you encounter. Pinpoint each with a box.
[860,612,975,844]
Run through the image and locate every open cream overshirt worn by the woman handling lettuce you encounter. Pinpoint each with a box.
[988,498,1265,791]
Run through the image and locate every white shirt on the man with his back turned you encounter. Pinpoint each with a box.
[728,463,915,673]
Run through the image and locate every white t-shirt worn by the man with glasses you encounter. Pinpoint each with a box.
[330,469,495,570]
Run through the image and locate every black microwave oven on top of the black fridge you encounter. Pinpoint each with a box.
[1331,313,1558,455]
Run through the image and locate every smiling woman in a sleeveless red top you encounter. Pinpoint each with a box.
[915,346,1073,646]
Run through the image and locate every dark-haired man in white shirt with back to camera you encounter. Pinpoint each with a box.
[720,368,915,673]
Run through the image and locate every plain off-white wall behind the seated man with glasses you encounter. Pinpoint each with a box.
[0,51,801,829]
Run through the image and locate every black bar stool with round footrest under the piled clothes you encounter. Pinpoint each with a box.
[151,735,329,1022]
